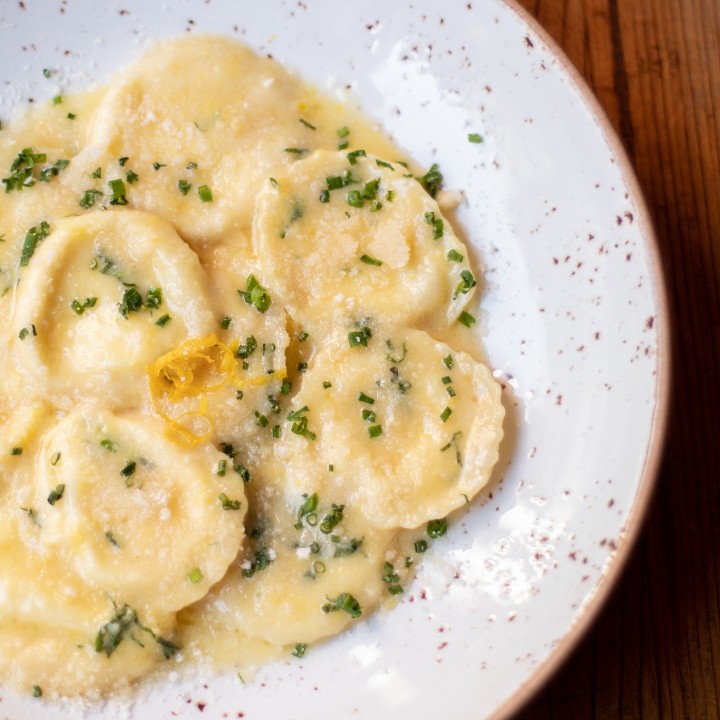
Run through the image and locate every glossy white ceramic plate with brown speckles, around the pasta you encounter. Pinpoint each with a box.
[0,0,668,720]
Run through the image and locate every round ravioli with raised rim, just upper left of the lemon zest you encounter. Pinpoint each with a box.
[10,211,216,405]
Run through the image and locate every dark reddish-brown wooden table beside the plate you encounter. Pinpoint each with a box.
[518,0,720,720]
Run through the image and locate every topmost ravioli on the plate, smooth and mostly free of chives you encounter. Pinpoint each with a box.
[88,37,318,245]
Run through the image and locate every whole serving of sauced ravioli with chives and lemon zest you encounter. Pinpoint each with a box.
[0,32,504,697]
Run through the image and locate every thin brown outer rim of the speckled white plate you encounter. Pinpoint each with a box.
[490,0,672,720]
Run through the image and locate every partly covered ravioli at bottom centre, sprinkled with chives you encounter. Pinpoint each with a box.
[181,488,396,650]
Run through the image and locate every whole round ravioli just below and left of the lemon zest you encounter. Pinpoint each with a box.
[35,407,247,612]
